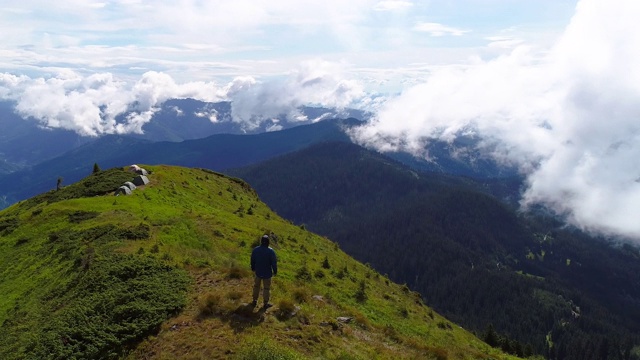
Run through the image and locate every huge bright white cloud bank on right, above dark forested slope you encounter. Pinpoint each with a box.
[355,0,640,240]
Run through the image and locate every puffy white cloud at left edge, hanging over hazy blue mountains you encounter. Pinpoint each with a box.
[0,70,218,136]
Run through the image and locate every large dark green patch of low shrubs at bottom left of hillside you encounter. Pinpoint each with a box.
[0,254,189,359]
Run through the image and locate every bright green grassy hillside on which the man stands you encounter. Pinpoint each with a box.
[0,166,520,359]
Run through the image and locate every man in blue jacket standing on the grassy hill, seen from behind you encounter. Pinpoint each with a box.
[251,235,278,309]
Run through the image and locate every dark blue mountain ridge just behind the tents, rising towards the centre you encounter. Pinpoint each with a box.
[0,119,357,207]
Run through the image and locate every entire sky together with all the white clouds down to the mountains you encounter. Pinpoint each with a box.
[0,0,640,239]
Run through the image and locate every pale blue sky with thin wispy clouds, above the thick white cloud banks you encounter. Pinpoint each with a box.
[0,0,576,92]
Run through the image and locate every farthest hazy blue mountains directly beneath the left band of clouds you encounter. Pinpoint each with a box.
[0,99,368,175]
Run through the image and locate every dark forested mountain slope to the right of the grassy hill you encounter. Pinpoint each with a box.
[232,142,640,360]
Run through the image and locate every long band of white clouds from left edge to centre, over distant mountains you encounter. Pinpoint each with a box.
[0,60,364,136]
